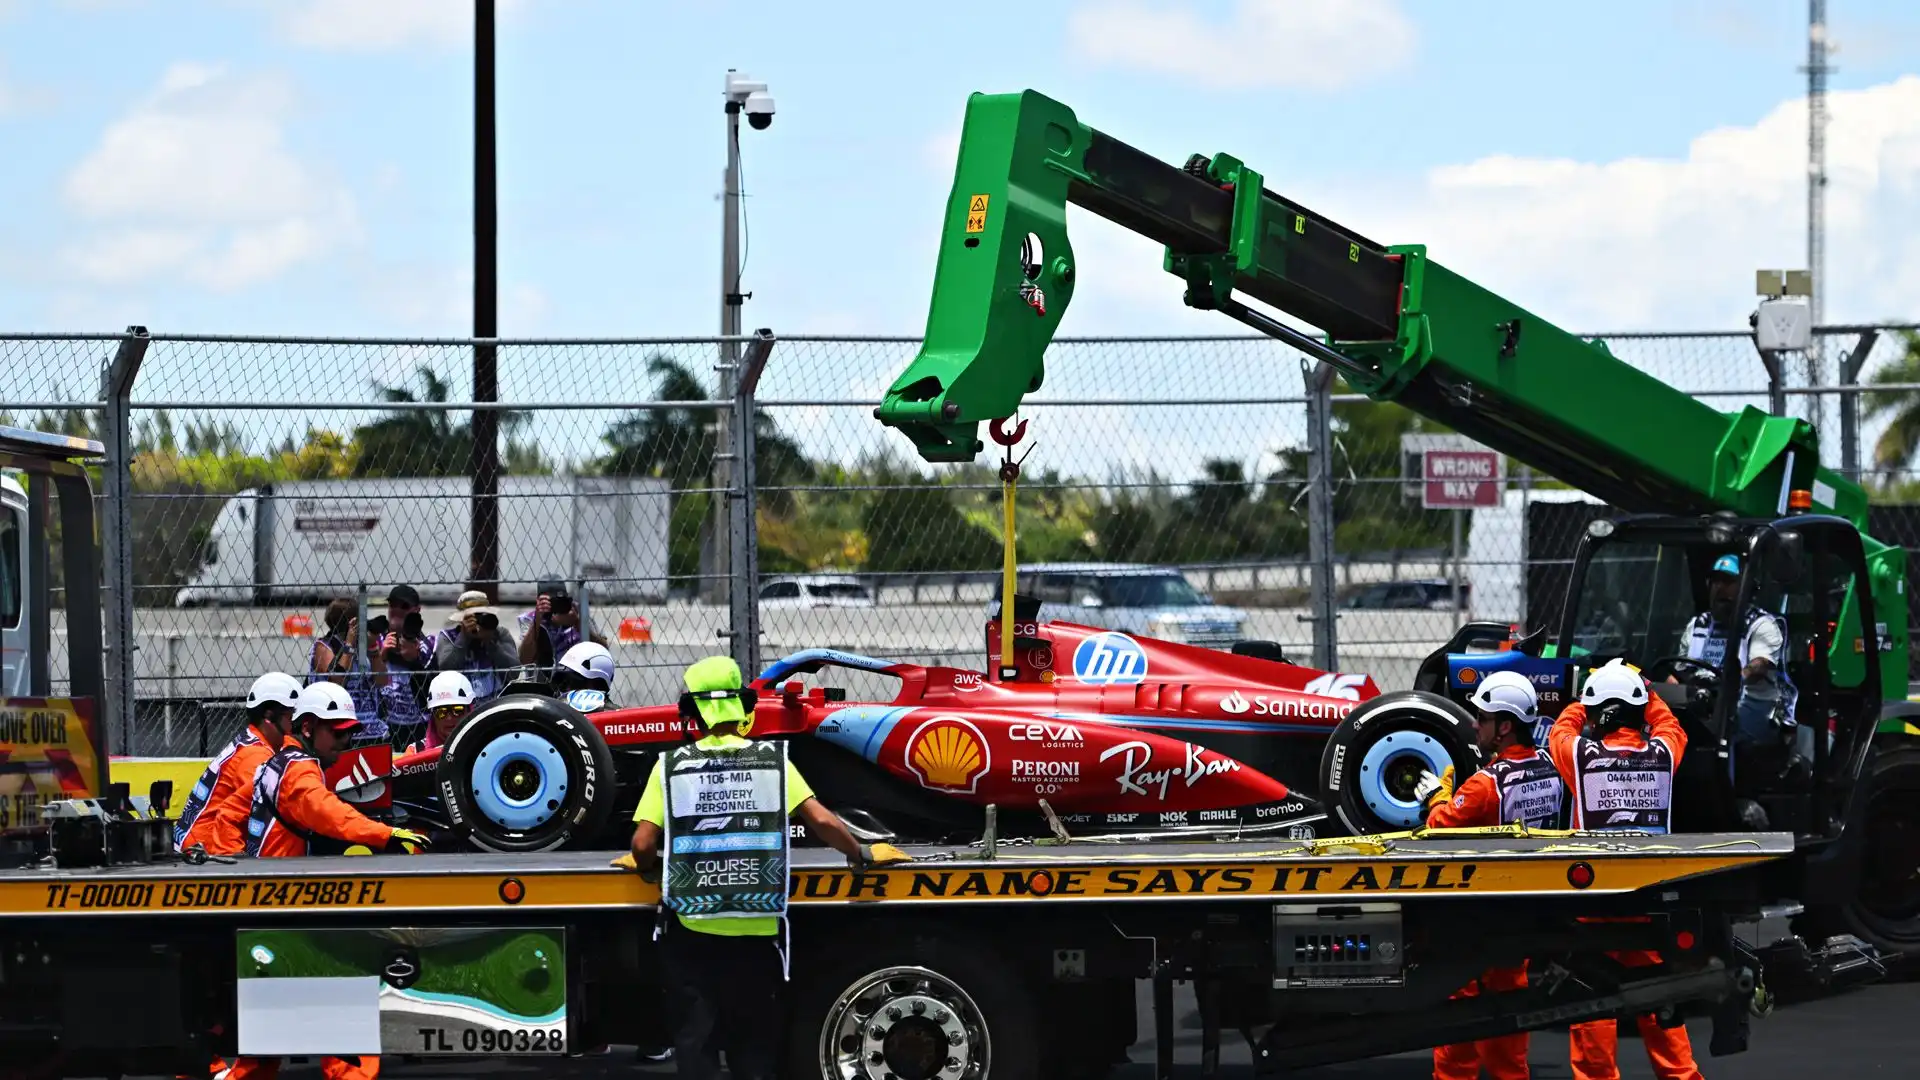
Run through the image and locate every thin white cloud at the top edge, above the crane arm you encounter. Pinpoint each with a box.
[1068,0,1415,90]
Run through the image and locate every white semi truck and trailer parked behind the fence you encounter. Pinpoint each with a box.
[174,477,670,607]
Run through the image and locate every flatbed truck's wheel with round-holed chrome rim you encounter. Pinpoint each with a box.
[787,934,1041,1080]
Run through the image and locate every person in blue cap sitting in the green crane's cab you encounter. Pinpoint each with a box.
[1668,555,1799,746]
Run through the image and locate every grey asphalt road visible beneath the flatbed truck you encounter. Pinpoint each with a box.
[228,982,1920,1080]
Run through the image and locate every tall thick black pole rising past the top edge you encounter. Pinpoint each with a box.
[467,0,499,600]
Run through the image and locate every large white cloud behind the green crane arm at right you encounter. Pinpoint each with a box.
[1068,75,1920,338]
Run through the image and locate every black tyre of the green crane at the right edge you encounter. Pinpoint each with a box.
[1837,742,1920,959]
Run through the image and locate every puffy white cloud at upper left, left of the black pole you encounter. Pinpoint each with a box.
[61,63,359,292]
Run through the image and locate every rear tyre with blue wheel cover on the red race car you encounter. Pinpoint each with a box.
[1319,690,1480,832]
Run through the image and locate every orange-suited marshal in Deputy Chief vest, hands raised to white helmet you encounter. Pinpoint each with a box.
[1548,659,1701,1080]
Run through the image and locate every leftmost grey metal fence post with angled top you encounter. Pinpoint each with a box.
[100,327,148,748]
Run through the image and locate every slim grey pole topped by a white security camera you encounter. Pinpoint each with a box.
[718,67,774,607]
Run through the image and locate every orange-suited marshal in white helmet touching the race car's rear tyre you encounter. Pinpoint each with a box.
[1413,671,1567,1080]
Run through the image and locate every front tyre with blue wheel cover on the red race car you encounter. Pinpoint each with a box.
[434,694,614,851]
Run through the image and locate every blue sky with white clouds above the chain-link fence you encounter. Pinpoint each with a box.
[0,0,1920,334]
